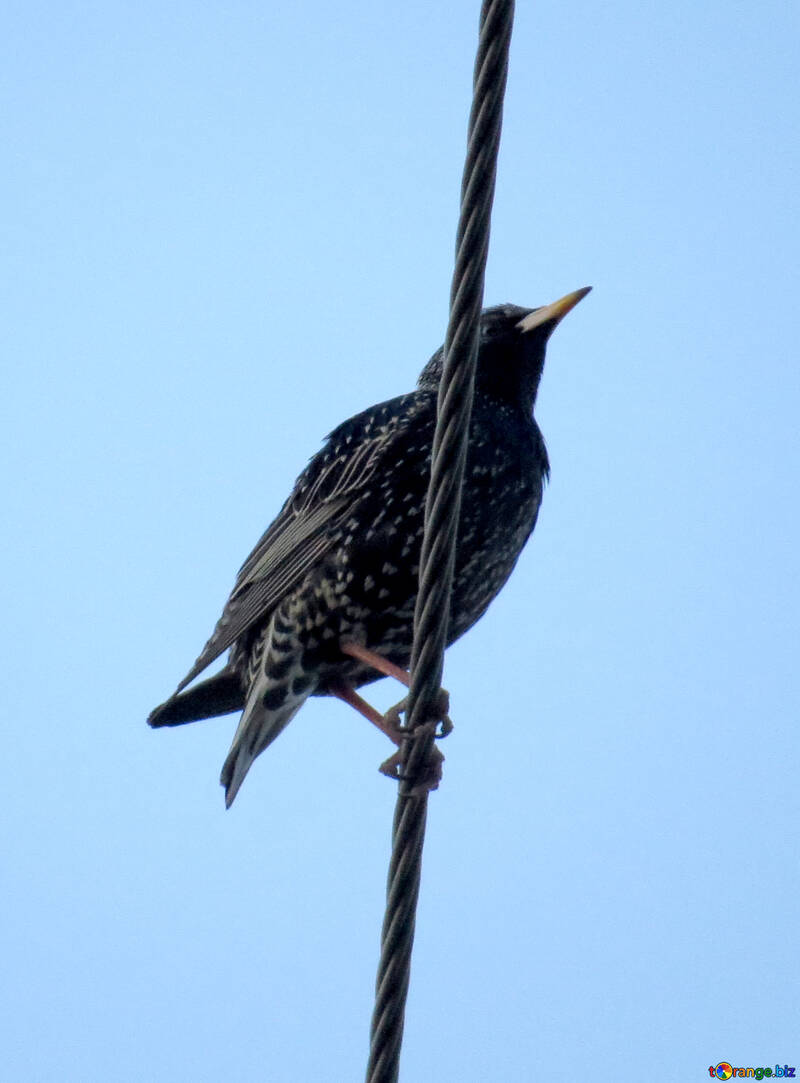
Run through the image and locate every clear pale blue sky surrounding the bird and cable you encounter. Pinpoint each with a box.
[0,0,800,1083]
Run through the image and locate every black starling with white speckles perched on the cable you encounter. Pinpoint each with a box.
[147,287,591,808]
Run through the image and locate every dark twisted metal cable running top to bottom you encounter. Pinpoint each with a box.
[367,0,514,1083]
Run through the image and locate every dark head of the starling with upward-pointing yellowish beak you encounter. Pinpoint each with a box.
[419,286,591,413]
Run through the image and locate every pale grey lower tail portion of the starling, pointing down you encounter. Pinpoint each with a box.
[220,669,313,809]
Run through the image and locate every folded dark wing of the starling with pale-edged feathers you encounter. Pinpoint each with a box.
[175,392,434,694]
